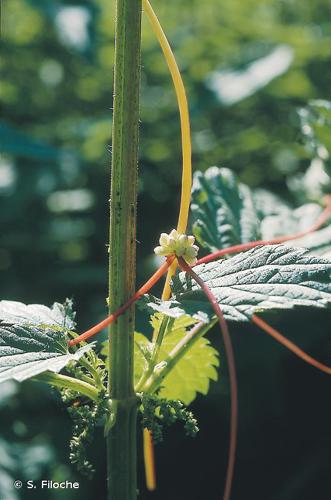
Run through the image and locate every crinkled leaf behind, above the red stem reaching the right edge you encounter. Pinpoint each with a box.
[191,167,330,255]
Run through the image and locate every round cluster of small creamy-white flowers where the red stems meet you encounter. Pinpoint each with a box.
[154,229,199,266]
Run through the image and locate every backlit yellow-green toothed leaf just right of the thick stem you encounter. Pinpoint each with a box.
[135,315,219,405]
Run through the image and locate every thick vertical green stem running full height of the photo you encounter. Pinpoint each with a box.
[108,0,141,500]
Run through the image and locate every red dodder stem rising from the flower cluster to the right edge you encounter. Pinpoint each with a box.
[197,195,331,264]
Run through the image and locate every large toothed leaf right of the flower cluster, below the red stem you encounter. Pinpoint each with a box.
[148,245,331,321]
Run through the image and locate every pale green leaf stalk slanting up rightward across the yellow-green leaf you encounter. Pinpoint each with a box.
[140,319,217,393]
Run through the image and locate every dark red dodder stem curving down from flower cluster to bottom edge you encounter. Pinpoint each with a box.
[177,257,238,500]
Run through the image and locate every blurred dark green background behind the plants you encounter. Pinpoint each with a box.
[0,0,331,500]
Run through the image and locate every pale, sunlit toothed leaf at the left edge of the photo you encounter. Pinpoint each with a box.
[0,300,91,382]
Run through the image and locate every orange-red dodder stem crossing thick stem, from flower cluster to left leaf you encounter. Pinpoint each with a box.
[69,256,175,347]
